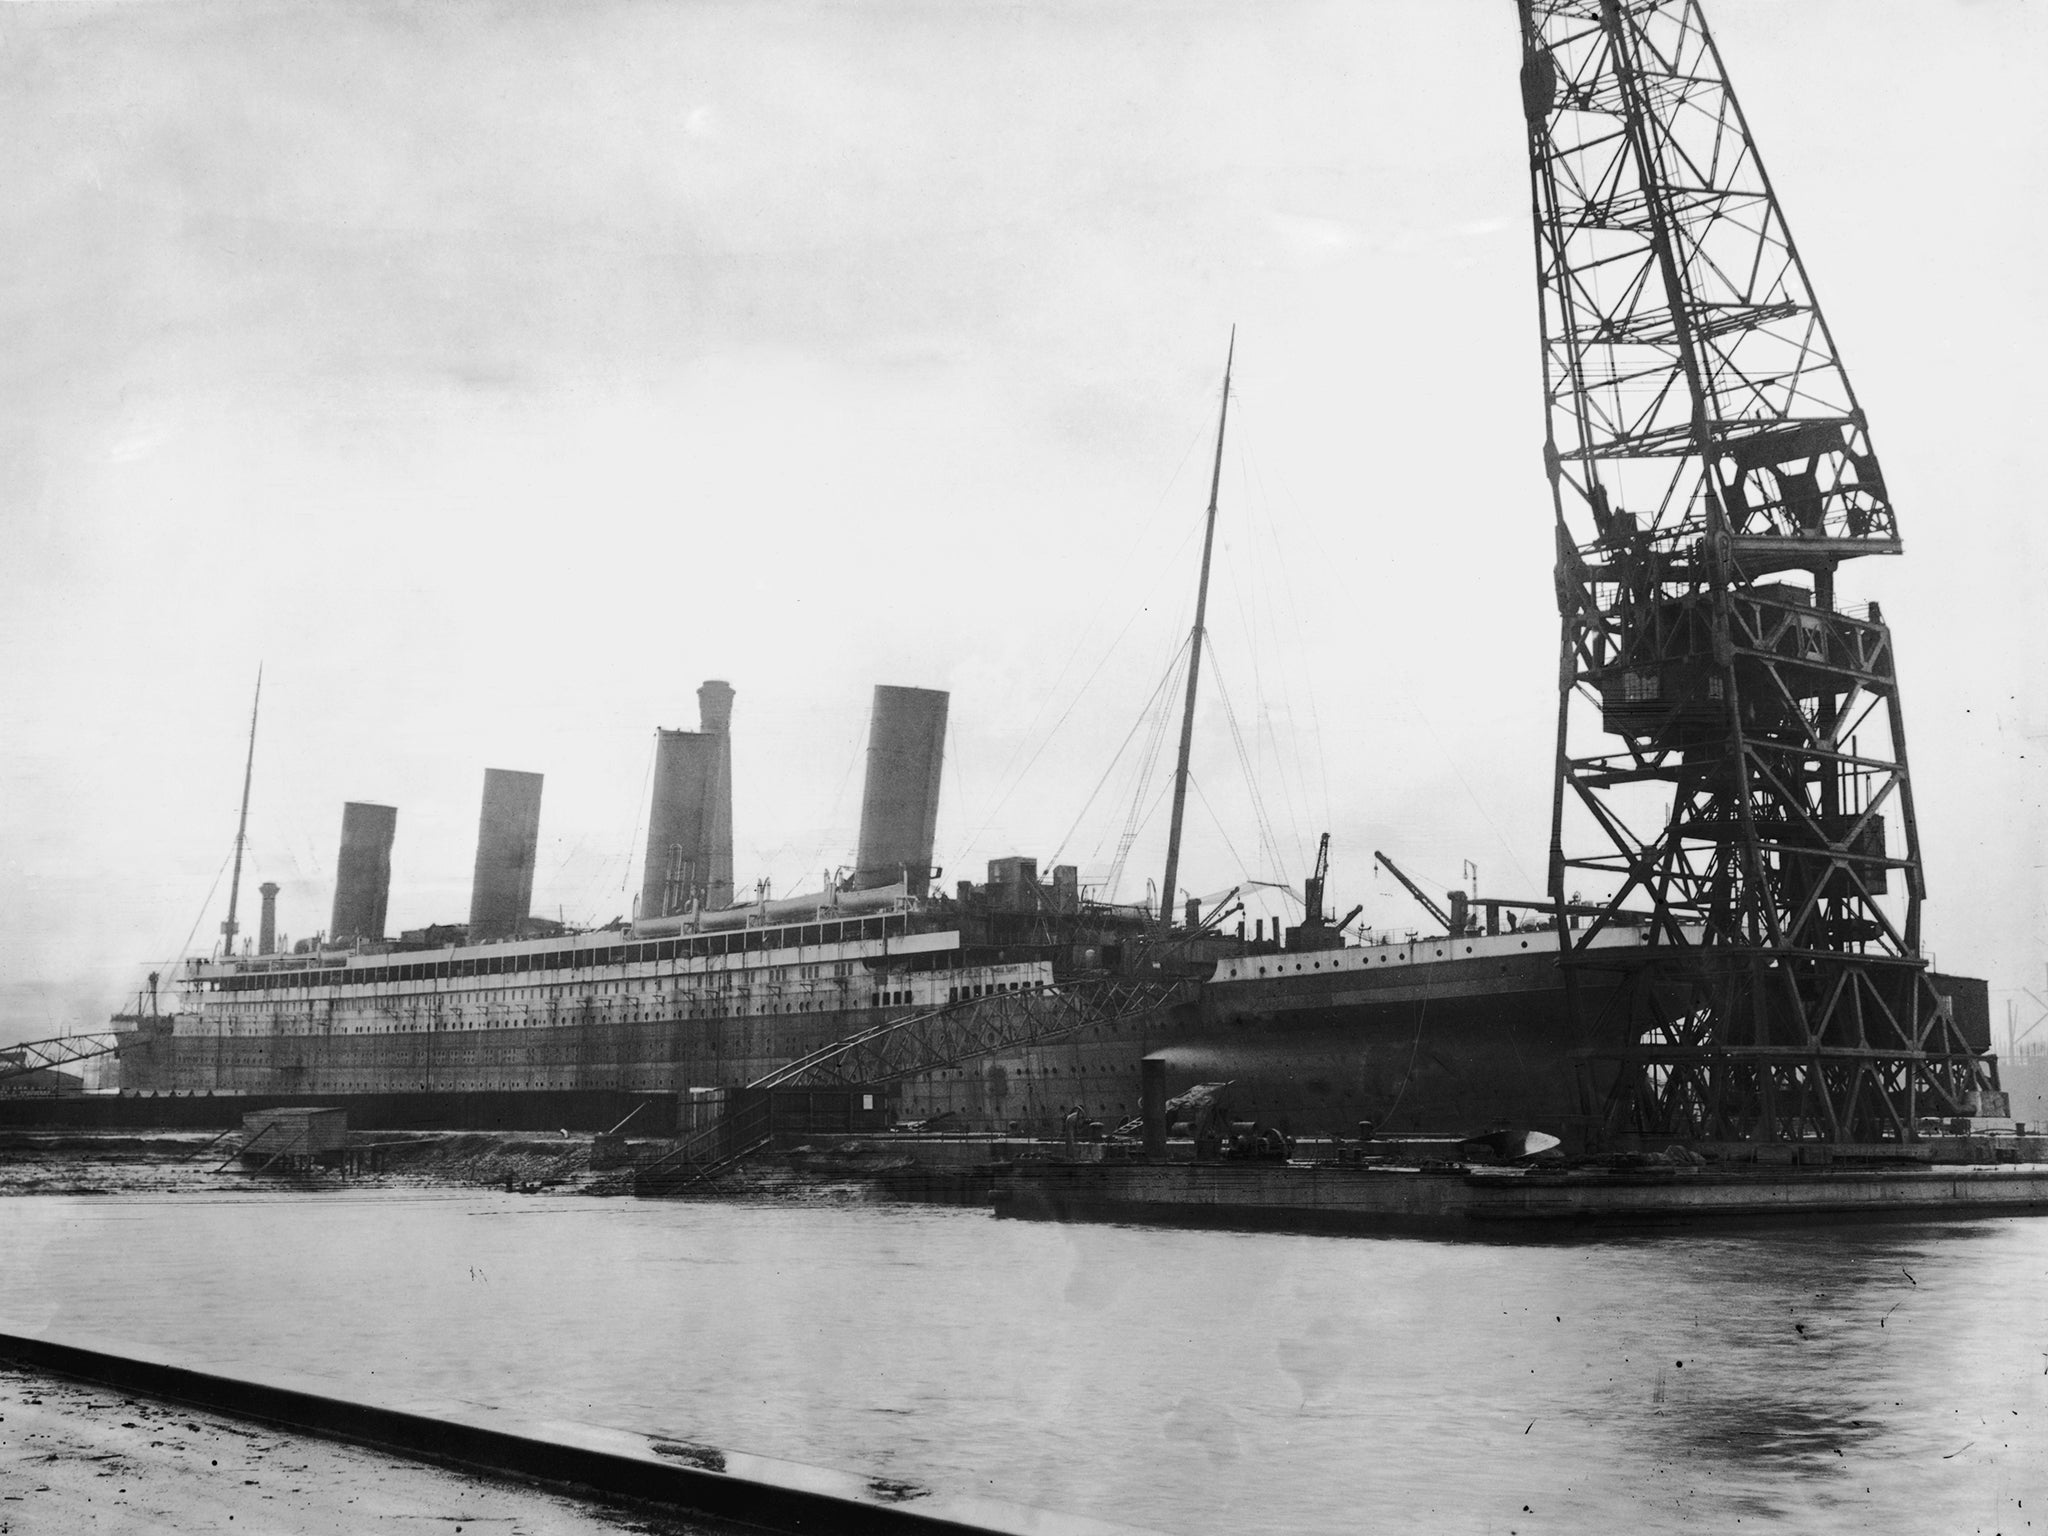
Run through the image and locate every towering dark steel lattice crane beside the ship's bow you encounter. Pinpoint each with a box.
[1518,0,1991,1141]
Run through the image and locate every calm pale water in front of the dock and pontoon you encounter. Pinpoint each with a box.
[0,1192,2048,1536]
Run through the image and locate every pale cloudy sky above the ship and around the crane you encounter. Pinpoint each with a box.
[0,0,2048,1038]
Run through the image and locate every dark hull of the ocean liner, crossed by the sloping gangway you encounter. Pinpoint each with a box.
[121,934,1634,1137]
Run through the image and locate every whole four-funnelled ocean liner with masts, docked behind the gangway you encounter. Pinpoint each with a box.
[103,342,1991,1139]
